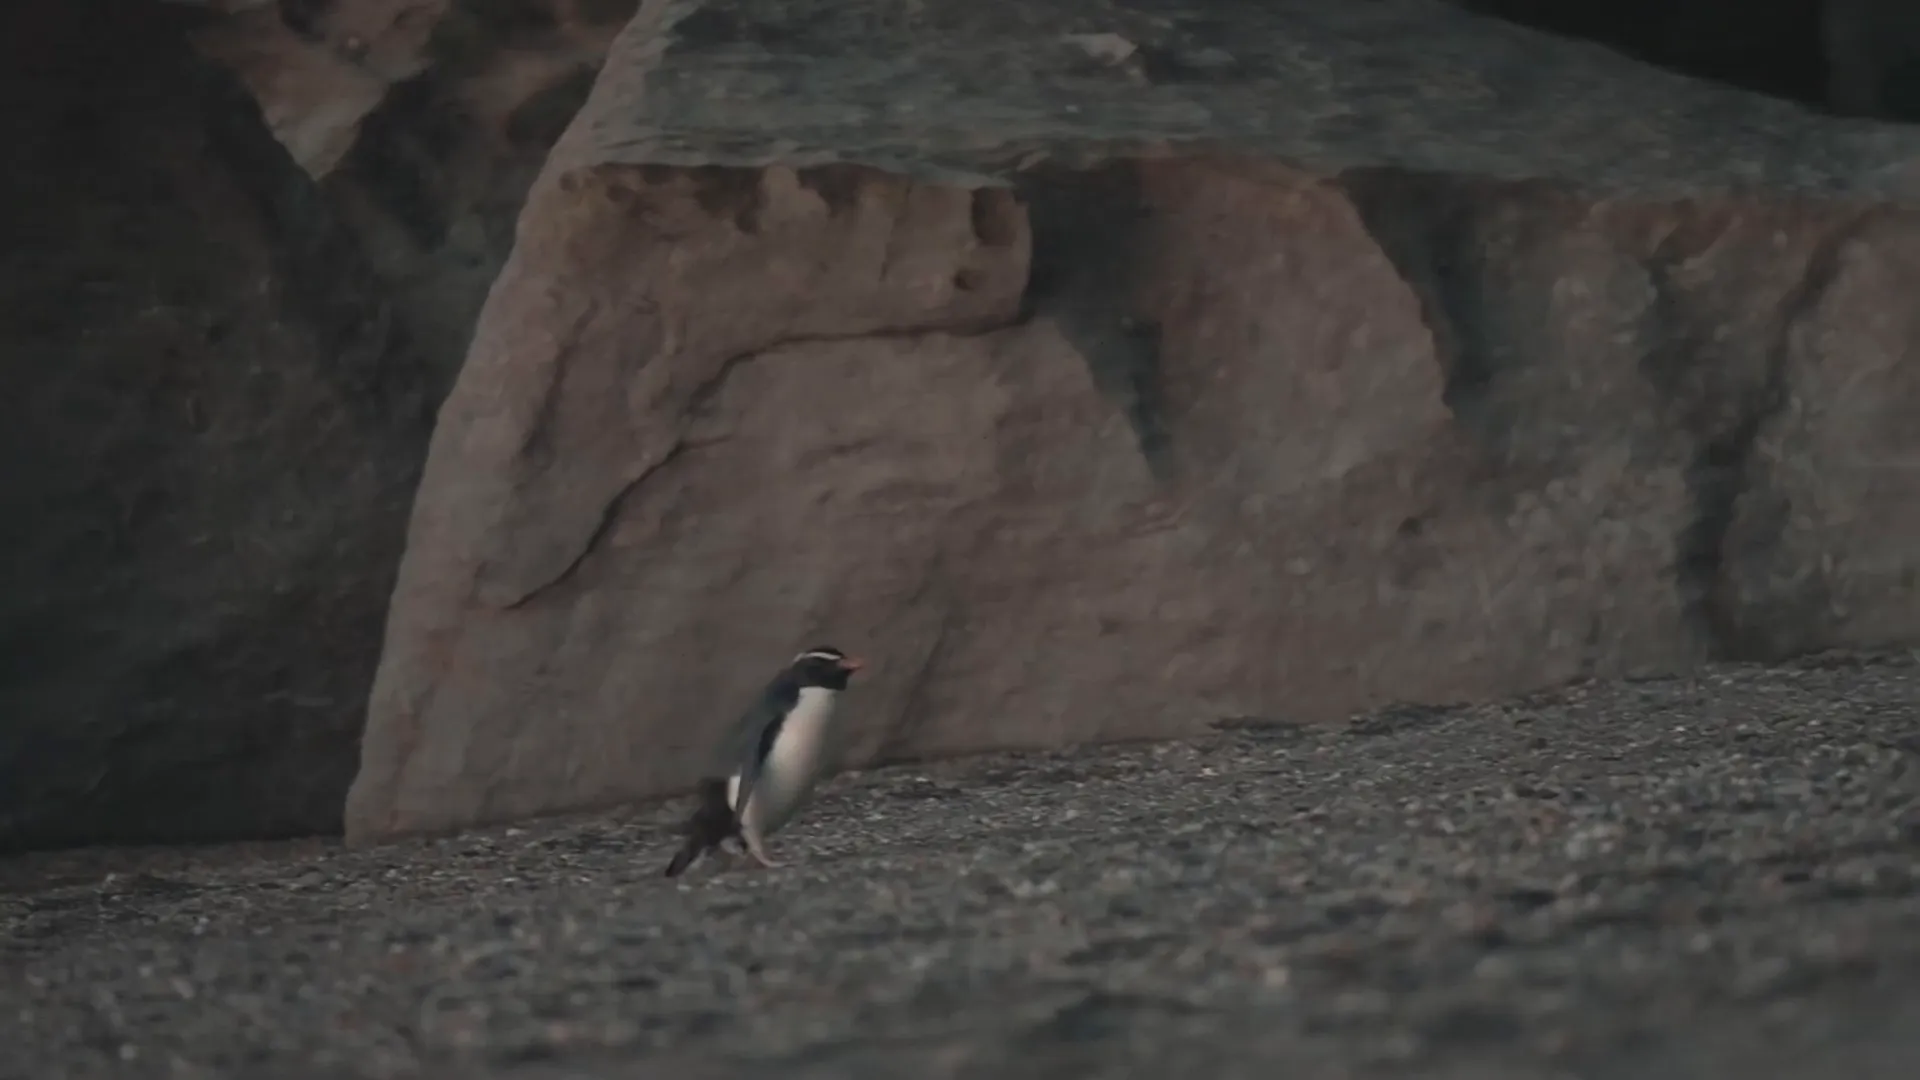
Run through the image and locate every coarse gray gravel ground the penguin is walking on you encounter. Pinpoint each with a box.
[11,659,1920,1080]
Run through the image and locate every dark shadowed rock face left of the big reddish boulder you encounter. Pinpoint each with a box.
[0,0,634,849]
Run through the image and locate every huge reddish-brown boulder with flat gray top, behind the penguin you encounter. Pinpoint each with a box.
[346,0,1920,840]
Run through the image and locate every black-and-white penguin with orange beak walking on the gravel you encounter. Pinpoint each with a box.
[666,646,862,878]
